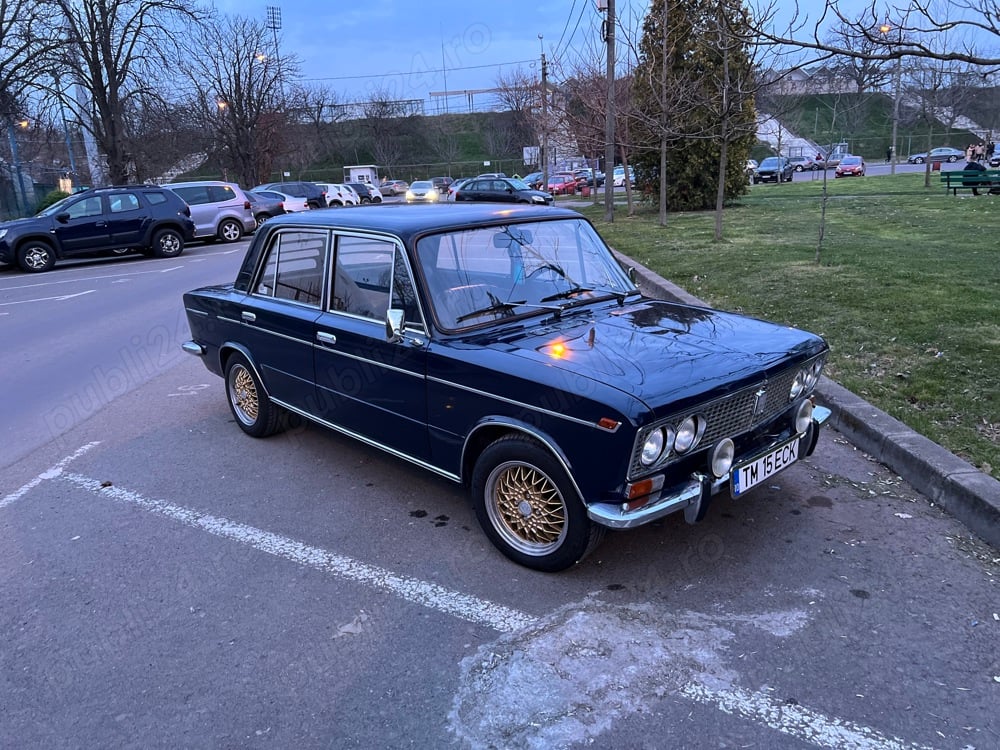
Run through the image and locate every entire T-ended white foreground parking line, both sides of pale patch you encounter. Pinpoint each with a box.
[0,442,932,750]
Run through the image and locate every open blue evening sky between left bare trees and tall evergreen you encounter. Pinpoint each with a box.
[214,0,649,106]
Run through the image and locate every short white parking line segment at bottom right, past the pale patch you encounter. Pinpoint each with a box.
[681,683,933,750]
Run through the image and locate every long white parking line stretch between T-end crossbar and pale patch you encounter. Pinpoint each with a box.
[60,474,536,633]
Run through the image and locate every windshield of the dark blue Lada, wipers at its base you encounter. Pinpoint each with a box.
[416,219,637,330]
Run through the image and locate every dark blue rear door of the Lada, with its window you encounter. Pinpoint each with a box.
[239,228,330,414]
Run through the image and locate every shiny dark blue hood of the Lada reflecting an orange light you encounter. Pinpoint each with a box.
[488,300,827,416]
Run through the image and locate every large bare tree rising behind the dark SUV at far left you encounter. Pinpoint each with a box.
[46,0,203,184]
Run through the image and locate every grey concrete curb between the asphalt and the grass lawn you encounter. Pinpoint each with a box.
[615,252,1000,547]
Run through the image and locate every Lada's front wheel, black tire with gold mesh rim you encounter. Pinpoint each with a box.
[472,435,605,573]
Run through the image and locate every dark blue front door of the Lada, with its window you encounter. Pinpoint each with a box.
[315,234,429,461]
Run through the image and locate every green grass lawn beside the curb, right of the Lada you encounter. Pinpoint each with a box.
[583,173,1000,478]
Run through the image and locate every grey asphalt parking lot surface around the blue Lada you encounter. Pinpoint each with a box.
[0,220,1000,750]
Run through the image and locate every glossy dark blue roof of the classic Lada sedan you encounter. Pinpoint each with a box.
[266,203,583,240]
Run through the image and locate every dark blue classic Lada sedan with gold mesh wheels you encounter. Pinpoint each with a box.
[183,204,830,571]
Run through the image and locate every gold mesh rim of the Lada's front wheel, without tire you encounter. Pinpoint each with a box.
[486,461,567,555]
